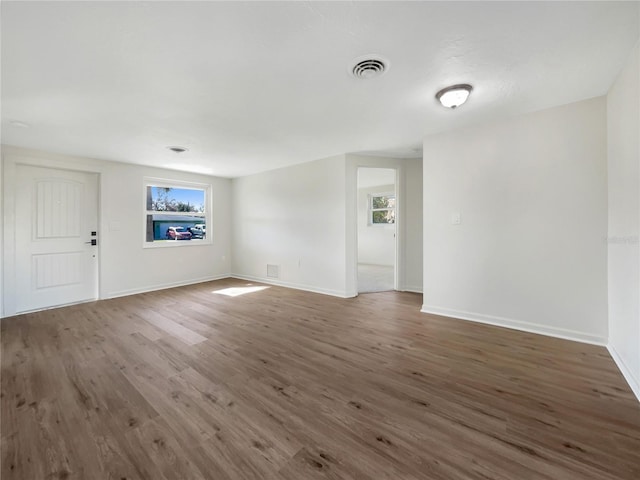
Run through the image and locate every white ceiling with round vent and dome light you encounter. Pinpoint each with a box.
[0,1,639,177]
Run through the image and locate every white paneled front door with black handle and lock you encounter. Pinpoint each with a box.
[15,165,98,313]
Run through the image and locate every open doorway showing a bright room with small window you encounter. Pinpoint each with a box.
[357,167,397,293]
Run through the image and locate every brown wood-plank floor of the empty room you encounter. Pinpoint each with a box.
[1,279,640,480]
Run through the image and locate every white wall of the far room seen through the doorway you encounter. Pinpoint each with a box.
[358,183,396,266]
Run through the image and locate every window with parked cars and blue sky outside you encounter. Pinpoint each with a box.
[145,179,211,247]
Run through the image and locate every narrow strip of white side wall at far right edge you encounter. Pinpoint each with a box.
[607,45,640,399]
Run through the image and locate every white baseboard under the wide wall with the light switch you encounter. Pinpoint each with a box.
[420,305,607,347]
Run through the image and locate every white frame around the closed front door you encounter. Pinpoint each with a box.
[0,153,104,317]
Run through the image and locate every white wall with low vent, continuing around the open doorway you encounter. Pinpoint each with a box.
[232,155,422,297]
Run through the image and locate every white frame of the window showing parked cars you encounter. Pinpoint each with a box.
[142,177,213,248]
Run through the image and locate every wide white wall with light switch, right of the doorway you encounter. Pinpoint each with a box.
[423,97,608,344]
